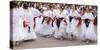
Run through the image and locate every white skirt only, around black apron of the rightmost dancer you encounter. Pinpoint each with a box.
[80,22,97,40]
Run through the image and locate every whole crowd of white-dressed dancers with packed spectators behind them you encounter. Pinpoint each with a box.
[10,1,97,43]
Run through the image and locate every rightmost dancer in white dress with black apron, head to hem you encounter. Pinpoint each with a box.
[80,6,97,43]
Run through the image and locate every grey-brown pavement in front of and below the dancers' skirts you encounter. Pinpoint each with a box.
[14,26,97,49]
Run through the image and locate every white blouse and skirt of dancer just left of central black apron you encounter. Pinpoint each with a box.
[40,10,53,35]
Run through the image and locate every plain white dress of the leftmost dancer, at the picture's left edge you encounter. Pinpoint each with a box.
[13,7,27,41]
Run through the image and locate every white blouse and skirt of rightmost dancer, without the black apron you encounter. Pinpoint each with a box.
[80,13,97,40]
